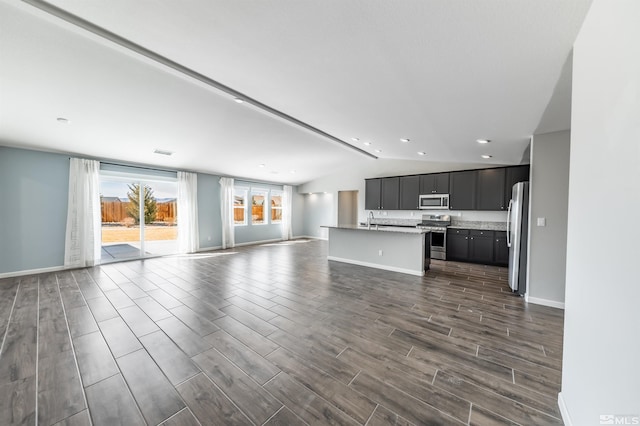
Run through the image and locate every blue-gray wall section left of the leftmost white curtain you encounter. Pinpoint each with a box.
[0,146,69,273]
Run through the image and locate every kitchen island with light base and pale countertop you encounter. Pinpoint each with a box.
[323,225,431,276]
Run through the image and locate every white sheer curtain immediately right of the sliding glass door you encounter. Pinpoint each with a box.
[178,172,200,253]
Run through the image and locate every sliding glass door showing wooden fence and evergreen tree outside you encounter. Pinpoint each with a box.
[100,175,178,263]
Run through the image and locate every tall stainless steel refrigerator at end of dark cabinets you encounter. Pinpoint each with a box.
[507,182,529,295]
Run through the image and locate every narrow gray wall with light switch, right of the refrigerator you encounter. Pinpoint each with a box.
[527,131,571,307]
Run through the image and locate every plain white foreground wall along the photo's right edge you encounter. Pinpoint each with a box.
[559,0,640,426]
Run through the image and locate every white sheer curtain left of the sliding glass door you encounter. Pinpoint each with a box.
[64,158,102,268]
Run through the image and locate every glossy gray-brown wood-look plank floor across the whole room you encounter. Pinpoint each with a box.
[0,240,563,426]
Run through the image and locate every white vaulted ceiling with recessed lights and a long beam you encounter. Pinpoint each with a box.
[0,0,591,184]
